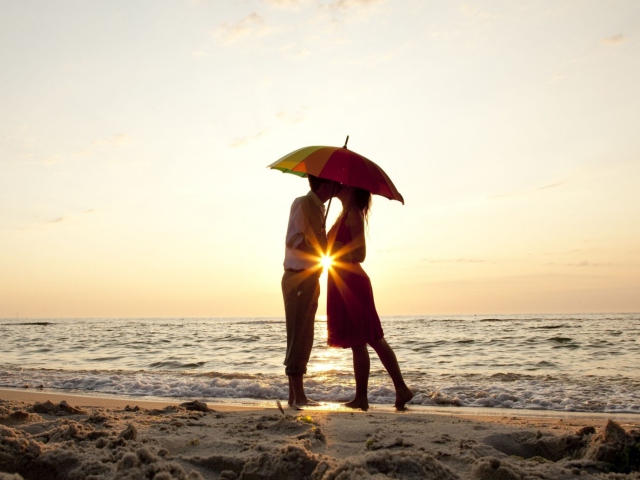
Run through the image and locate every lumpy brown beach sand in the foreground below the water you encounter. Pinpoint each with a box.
[0,390,640,480]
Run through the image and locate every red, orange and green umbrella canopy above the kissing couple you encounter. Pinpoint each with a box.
[269,137,404,205]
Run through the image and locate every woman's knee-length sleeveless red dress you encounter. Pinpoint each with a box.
[327,215,384,348]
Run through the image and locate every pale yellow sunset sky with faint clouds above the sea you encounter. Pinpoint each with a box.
[0,0,640,318]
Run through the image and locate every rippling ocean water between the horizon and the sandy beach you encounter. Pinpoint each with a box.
[0,313,640,413]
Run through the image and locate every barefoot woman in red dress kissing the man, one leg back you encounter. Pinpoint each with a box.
[327,185,413,411]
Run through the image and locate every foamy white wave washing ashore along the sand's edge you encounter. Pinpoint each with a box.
[0,368,640,414]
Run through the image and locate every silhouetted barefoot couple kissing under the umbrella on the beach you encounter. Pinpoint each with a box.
[282,175,413,410]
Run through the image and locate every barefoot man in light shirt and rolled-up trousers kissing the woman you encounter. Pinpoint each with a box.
[282,175,337,407]
